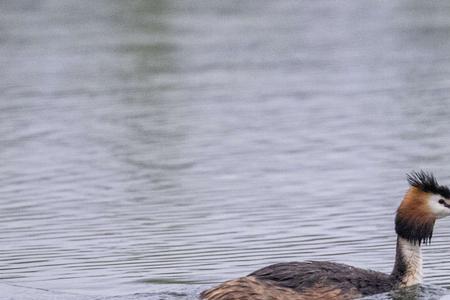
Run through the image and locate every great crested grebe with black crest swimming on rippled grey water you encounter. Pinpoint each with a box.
[200,171,450,300]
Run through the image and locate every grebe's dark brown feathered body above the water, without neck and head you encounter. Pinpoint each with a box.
[202,261,393,300]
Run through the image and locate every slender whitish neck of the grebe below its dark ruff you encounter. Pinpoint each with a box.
[394,237,422,287]
